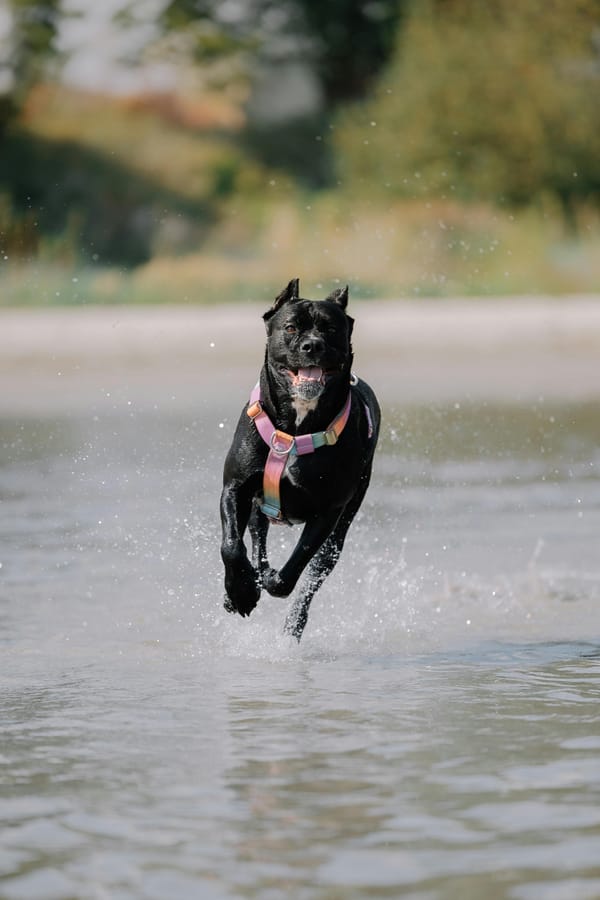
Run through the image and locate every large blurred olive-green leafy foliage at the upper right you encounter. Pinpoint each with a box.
[337,0,600,206]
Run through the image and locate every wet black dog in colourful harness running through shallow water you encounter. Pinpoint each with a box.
[221,279,380,640]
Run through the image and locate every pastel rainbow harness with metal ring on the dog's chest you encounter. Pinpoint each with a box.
[246,384,354,522]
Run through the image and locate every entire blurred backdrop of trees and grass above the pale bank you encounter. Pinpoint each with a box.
[0,0,600,306]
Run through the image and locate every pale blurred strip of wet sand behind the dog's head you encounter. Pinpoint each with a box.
[0,296,600,415]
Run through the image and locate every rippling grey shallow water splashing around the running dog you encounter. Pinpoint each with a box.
[0,306,600,900]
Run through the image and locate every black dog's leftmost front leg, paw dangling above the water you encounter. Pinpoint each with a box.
[221,482,260,616]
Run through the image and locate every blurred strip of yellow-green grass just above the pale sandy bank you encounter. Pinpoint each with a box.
[0,195,600,306]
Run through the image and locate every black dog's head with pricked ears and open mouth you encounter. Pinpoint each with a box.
[263,278,354,401]
